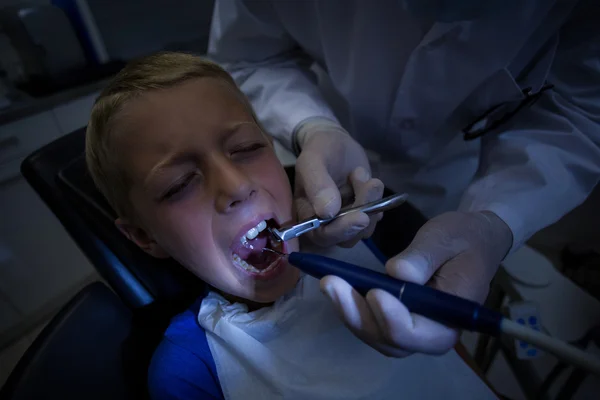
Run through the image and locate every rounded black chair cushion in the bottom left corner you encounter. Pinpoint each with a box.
[0,282,134,400]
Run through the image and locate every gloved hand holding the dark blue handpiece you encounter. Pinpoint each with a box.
[321,211,513,357]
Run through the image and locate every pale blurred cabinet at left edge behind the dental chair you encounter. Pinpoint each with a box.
[0,93,97,348]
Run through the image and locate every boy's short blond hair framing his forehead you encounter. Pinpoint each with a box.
[85,52,262,218]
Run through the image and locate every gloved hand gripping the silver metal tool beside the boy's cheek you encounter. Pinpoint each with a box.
[294,118,383,247]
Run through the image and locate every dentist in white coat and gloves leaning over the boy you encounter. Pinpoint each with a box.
[209,0,600,357]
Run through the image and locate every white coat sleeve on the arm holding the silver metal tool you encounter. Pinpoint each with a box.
[208,0,337,149]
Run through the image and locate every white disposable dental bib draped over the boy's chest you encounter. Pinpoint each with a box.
[198,242,496,400]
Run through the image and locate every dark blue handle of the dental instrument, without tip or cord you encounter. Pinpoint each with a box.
[288,252,503,335]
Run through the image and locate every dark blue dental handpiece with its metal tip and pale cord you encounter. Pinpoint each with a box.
[264,248,600,375]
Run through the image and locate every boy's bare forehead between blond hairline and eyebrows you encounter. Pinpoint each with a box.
[117,78,255,177]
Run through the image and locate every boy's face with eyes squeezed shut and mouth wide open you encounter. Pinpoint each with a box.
[116,78,298,303]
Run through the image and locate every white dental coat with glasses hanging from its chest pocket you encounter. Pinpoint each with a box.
[209,0,600,250]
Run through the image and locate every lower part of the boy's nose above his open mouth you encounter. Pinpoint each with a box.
[214,163,256,213]
